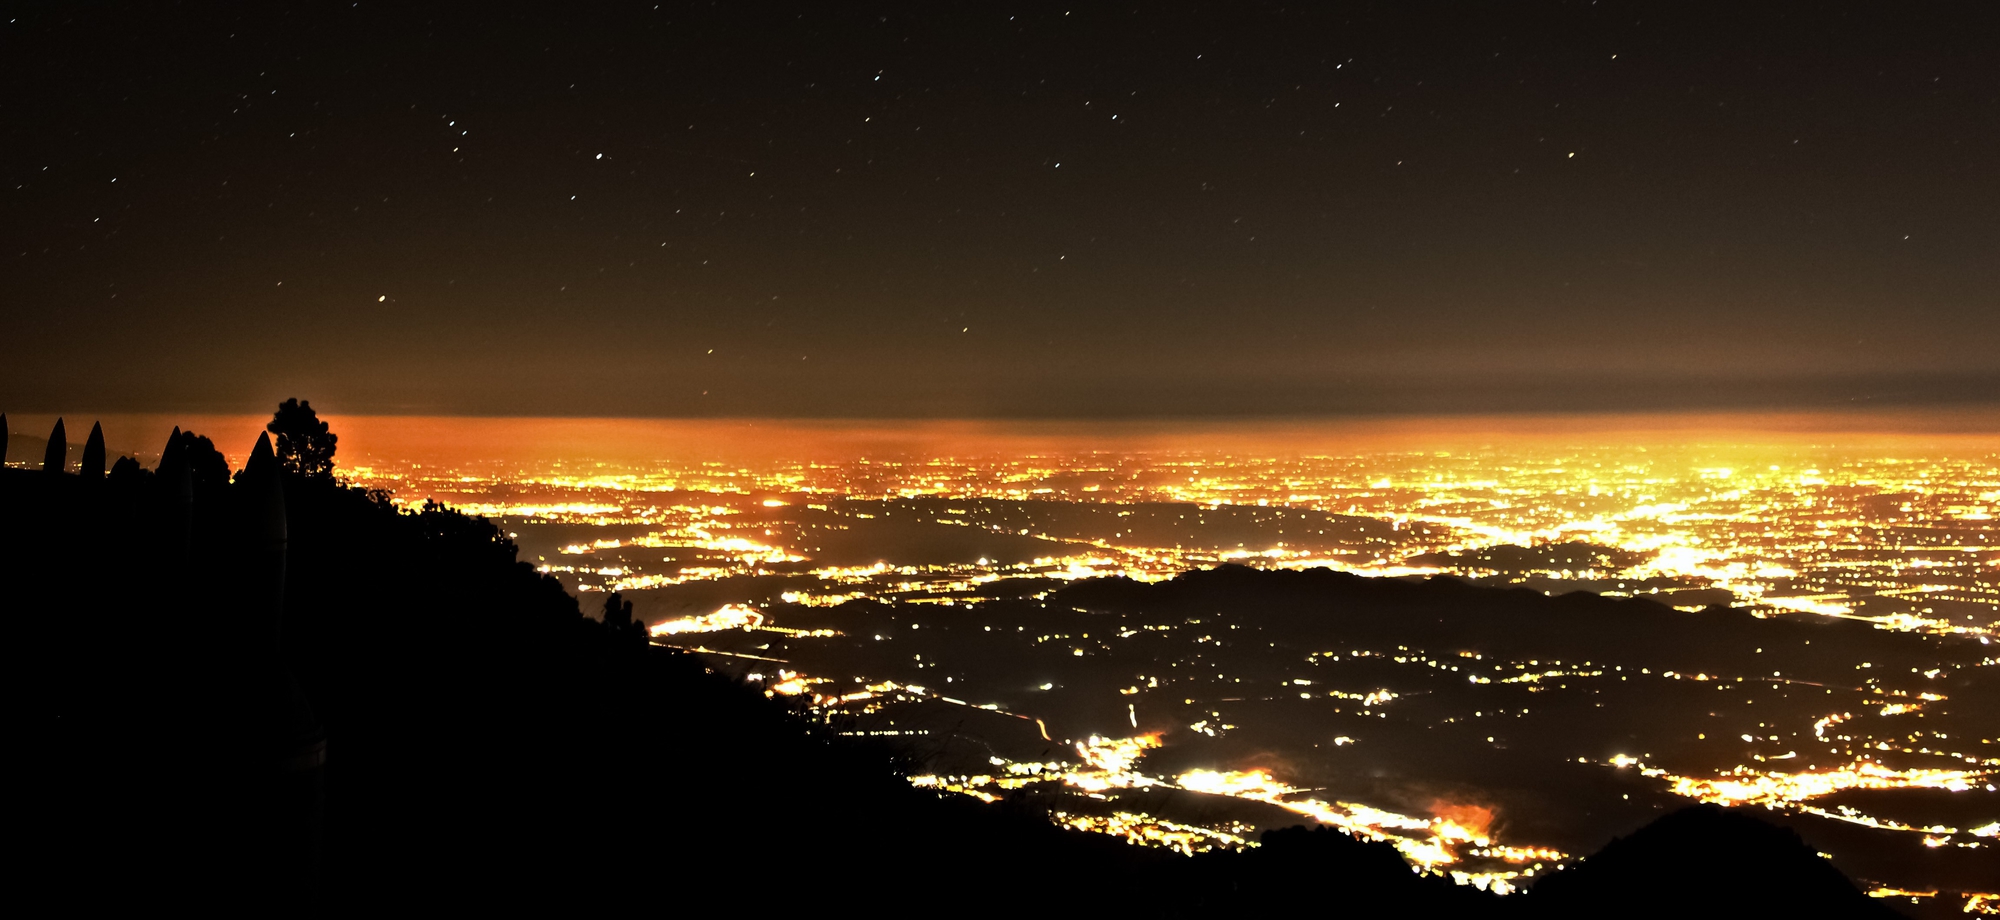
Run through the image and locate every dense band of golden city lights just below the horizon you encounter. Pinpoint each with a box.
[352,446,2000,634]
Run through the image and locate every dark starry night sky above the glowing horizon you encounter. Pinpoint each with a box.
[0,0,2000,416]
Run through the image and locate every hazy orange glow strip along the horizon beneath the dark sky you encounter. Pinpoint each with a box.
[12,410,2000,468]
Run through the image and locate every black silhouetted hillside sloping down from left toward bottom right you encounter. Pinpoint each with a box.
[0,444,1904,916]
